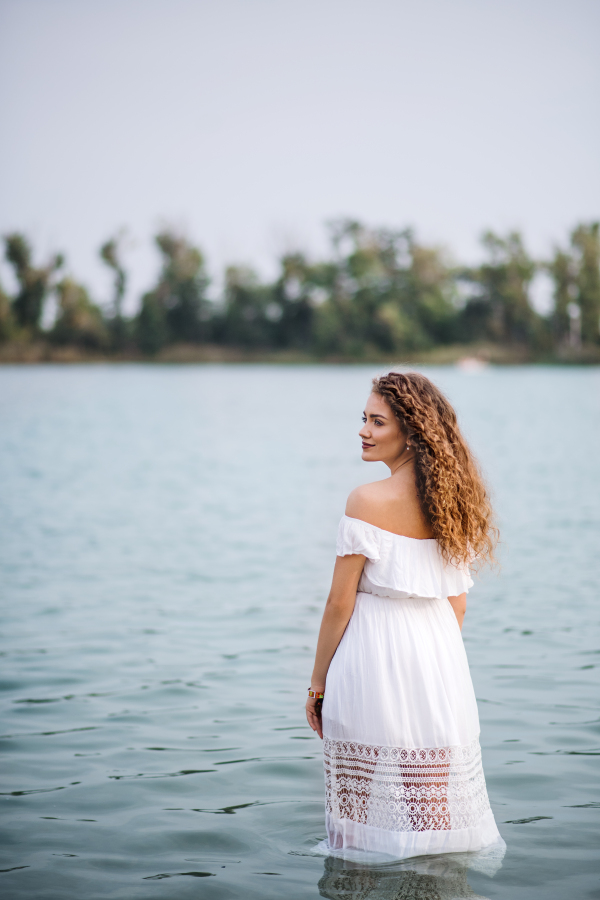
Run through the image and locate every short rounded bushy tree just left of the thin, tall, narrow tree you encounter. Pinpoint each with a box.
[51,277,108,350]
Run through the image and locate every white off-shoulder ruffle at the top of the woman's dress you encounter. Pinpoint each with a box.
[336,516,473,600]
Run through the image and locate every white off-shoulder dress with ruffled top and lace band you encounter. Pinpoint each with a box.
[320,516,503,859]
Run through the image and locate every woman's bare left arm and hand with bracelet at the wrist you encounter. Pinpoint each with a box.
[306,554,366,738]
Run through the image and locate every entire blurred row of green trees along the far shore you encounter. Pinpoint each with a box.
[0,219,600,359]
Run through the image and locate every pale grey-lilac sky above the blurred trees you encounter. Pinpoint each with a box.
[0,0,600,309]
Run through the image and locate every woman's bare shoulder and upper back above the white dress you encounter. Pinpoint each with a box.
[346,478,432,540]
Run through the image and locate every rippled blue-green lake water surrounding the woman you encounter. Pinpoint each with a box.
[0,365,600,900]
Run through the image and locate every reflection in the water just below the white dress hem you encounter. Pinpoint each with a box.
[319,856,486,900]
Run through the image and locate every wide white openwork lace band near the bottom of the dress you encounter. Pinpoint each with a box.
[323,738,490,831]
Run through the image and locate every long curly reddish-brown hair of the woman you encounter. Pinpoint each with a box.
[373,372,498,568]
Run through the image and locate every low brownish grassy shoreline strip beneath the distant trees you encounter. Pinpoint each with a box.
[0,341,600,369]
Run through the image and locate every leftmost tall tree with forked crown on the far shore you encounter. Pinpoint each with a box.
[4,232,64,333]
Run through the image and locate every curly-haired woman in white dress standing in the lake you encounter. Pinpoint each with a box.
[306,372,502,859]
